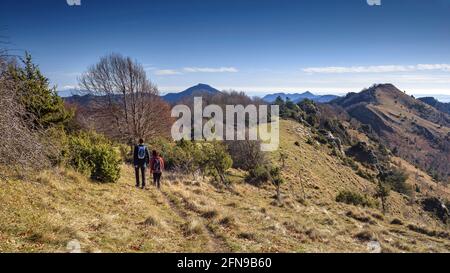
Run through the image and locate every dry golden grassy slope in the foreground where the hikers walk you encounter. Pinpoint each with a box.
[0,121,450,252]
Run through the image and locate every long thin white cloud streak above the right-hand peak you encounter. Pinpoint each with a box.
[303,64,450,74]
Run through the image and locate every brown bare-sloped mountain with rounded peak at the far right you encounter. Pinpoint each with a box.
[335,84,450,182]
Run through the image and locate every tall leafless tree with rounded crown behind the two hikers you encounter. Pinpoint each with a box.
[79,54,171,144]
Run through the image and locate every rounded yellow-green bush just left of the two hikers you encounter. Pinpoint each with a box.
[68,132,121,183]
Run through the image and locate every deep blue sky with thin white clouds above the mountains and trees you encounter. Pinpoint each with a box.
[0,0,450,95]
